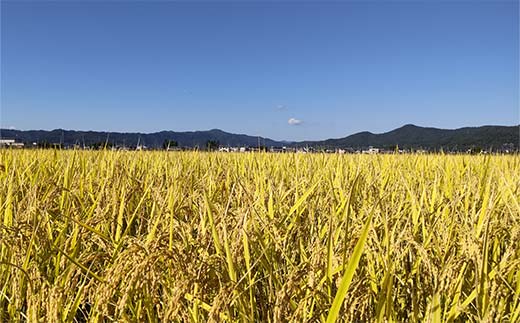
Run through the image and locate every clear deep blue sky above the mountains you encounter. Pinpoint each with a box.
[0,0,519,140]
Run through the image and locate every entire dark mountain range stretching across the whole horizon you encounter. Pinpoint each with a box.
[0,124,520,150]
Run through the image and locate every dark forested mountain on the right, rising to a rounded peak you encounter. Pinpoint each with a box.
[298,124,520,150]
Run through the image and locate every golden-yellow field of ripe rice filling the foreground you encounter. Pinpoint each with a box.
[0,150,520,322]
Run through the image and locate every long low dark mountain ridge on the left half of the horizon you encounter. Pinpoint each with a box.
[0,129,285,148]
